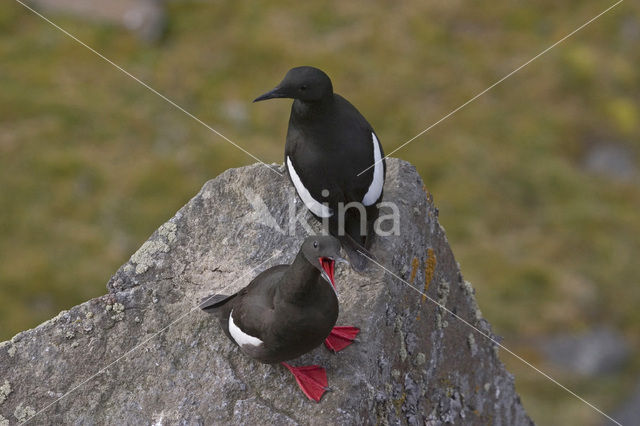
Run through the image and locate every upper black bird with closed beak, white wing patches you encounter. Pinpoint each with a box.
[254,66,386,270]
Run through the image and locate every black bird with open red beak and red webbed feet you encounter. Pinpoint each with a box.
[200,236,359,401]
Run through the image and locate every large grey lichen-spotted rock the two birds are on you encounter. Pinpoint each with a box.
[0,159,531,425]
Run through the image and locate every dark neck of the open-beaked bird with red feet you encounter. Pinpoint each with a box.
[279,251,322,301]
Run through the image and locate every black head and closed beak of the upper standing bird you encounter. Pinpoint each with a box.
[253,66,333,102]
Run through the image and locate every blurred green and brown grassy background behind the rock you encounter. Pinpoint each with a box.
[0,0,640,424]
